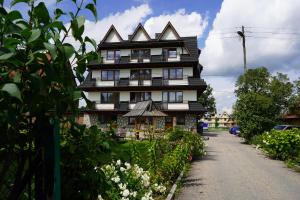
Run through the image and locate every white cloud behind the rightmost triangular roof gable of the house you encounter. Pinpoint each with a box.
[144,9,208,37]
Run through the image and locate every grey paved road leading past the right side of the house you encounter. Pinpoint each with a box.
[177,132,300,200]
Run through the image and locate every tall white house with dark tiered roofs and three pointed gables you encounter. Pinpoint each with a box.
[80,22,206,130]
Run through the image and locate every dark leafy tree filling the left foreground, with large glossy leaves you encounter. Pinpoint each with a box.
[0,0,99,199]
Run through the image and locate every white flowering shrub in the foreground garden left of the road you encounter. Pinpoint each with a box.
[95,160,166,200]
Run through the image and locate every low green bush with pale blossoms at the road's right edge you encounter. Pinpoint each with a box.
[262,129,300,160]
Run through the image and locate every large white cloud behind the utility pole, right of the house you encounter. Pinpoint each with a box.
[200,0,300,115]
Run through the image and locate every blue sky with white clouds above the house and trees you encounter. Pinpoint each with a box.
[5,0,300,113]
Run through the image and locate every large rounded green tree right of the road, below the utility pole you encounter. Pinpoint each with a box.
[234,67,292,142]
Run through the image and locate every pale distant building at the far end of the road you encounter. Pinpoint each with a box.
[202,111,236,128]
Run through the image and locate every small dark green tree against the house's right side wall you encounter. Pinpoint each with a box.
[198,84,216,114]
